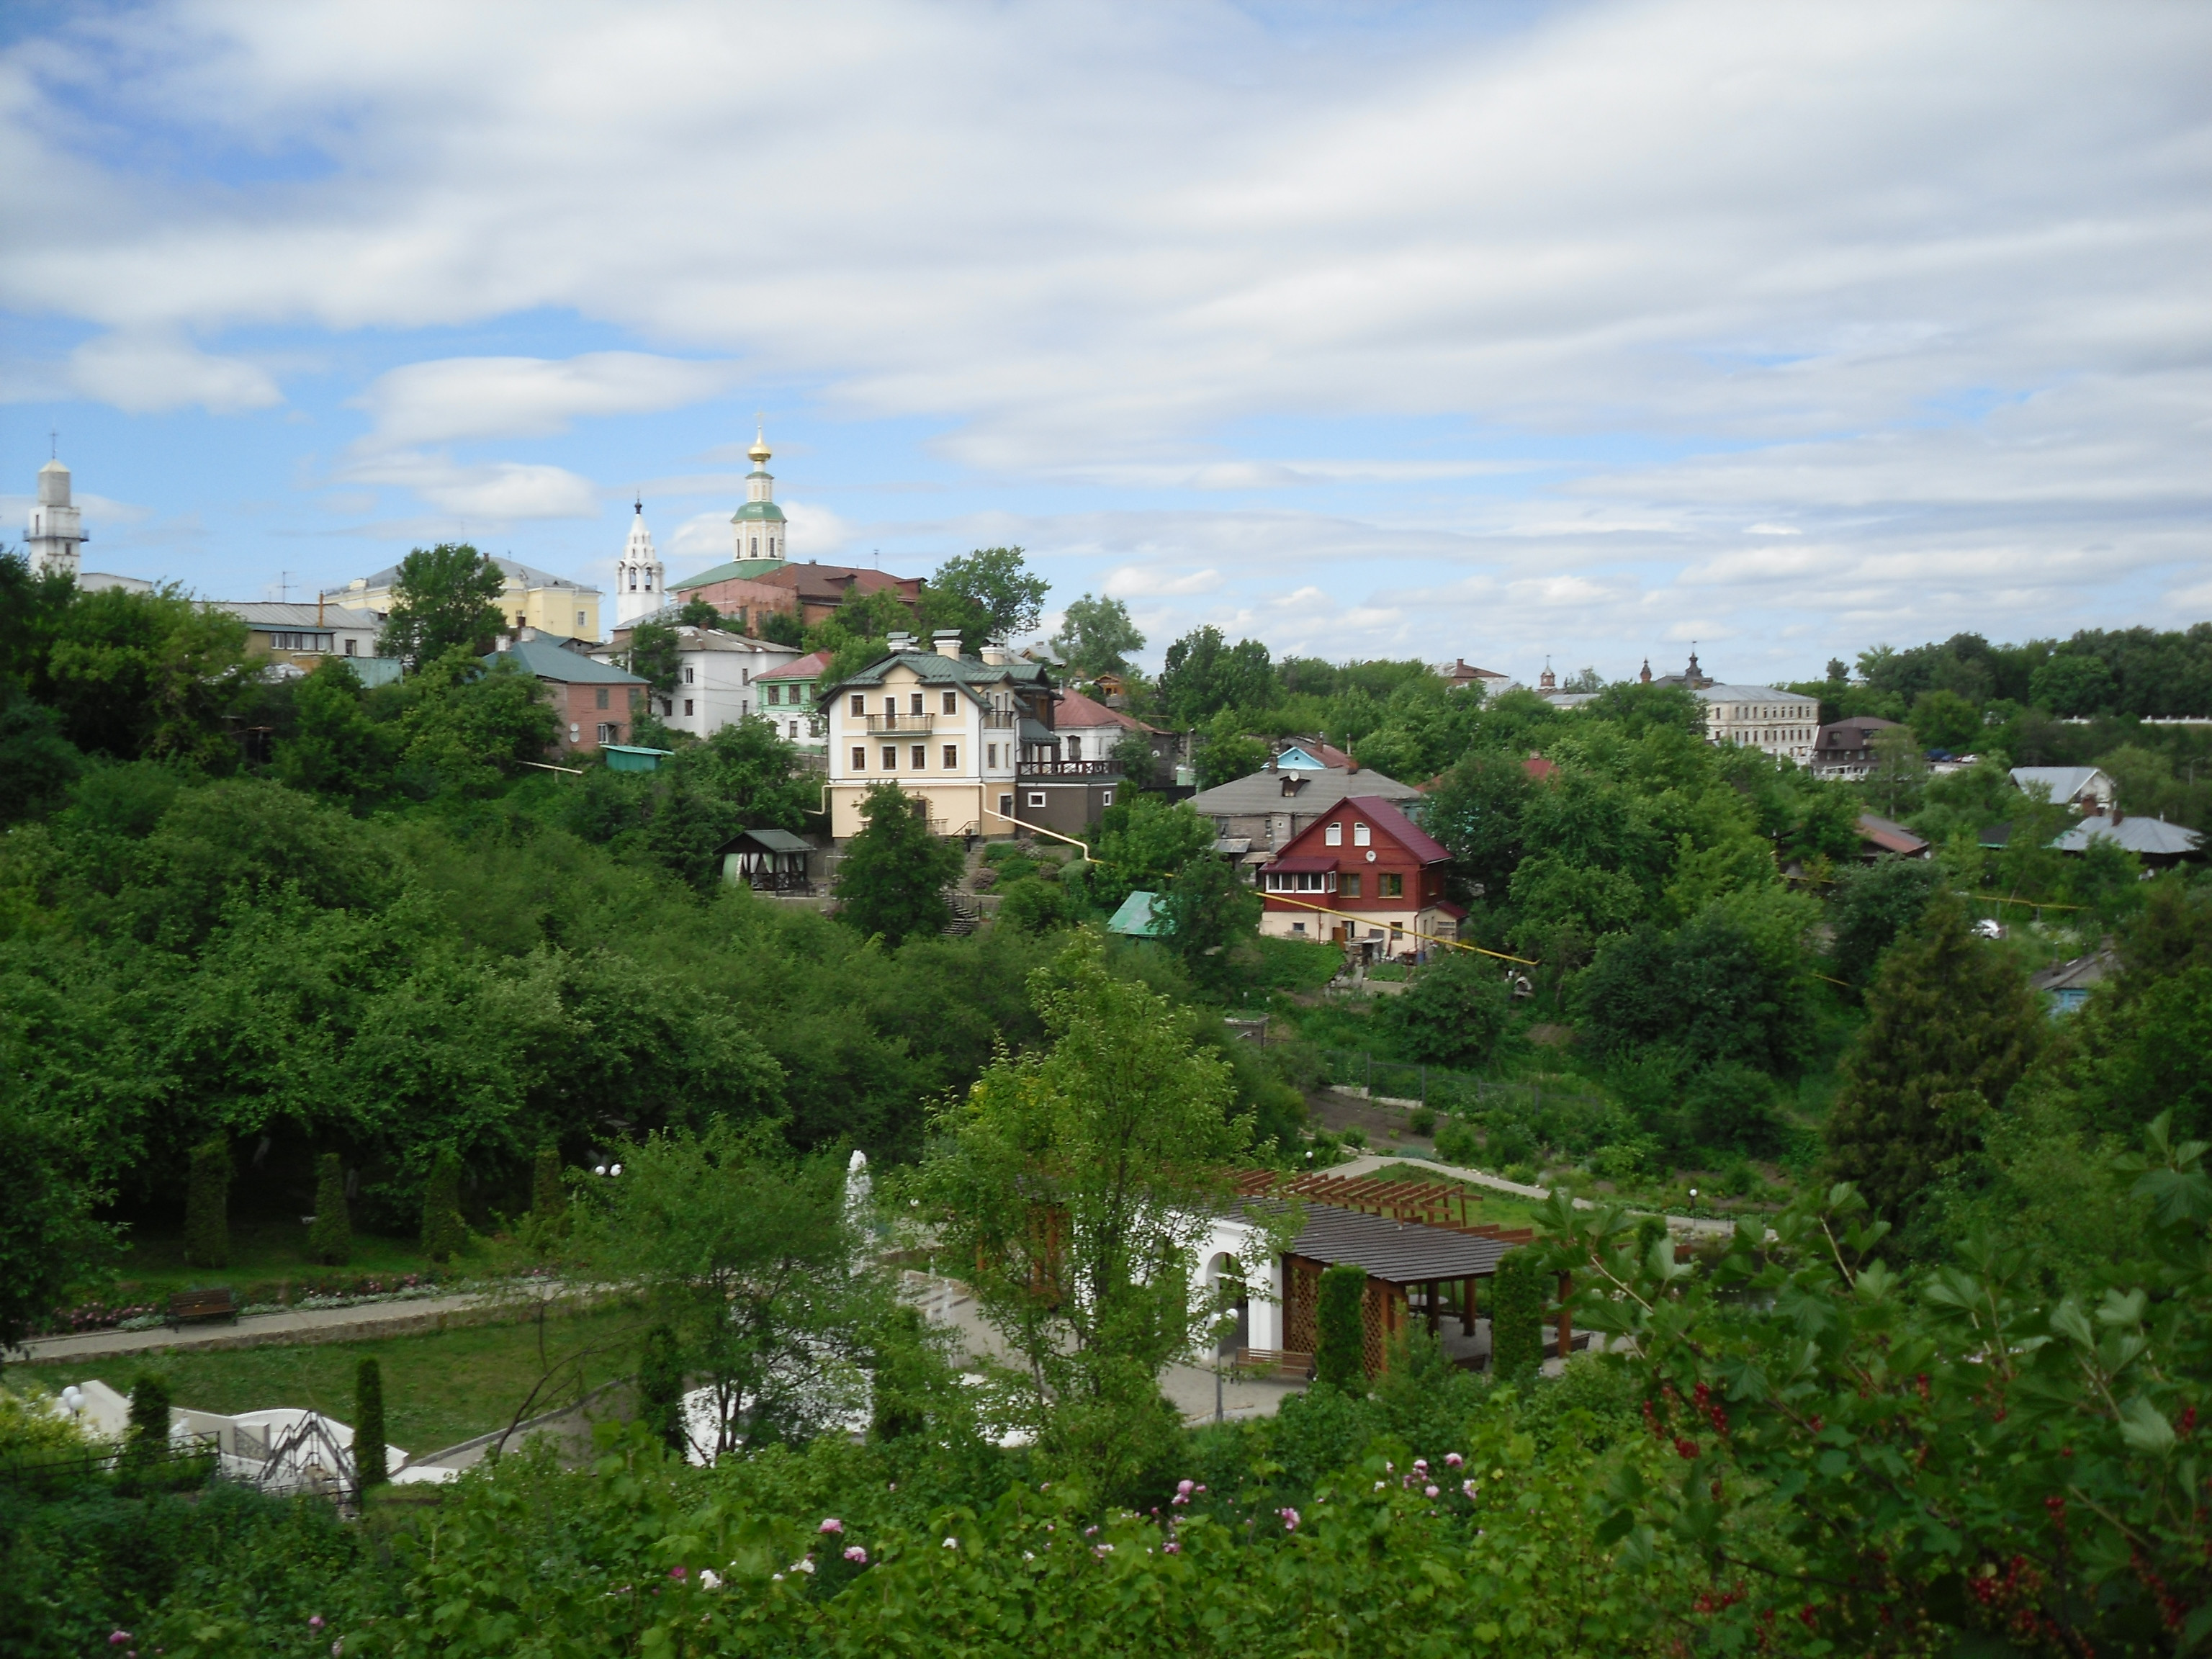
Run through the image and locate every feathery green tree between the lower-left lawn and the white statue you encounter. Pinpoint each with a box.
[577,1119,887,1455]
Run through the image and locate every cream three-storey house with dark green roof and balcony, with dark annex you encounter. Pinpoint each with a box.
[819,631,1126,840]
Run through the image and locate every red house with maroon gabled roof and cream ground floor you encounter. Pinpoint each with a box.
[1259,794,1467,958]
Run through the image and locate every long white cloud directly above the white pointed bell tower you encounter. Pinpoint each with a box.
[359,351,737,447]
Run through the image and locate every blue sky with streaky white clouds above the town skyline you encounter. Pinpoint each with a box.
[0,0,2212,681]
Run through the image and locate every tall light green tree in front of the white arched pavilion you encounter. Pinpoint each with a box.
[920,931,1252,1493]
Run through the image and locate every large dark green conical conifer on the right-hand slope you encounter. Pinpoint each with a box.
[1827,896,2046,1223]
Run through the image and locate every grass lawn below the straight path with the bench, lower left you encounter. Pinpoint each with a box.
[24,1308,646,1455]
